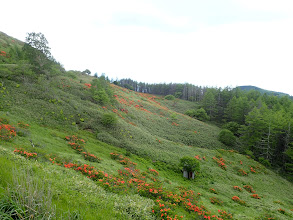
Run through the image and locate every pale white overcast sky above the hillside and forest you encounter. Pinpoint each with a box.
[0,0,293,95]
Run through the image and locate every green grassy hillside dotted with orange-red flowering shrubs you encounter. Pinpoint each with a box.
[0,31,293,219]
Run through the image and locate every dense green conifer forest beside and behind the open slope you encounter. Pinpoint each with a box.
[114,79,293,180]
